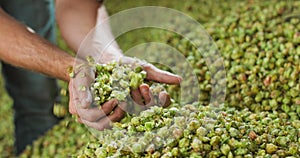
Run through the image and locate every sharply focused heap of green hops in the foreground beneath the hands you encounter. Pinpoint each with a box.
[78,102,300,158]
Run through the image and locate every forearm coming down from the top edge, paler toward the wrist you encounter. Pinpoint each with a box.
[56,0,122,62]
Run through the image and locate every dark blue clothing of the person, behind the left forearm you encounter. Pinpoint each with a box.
[0,0,59,154]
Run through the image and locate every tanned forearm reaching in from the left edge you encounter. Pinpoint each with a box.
[0,8,74,81]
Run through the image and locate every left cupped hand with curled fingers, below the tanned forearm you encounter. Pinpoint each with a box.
[69,65,126,130]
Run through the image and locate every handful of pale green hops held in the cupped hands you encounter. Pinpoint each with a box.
[91,62,146,105]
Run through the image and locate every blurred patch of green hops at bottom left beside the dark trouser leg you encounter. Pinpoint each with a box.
[19,117,96,158]
